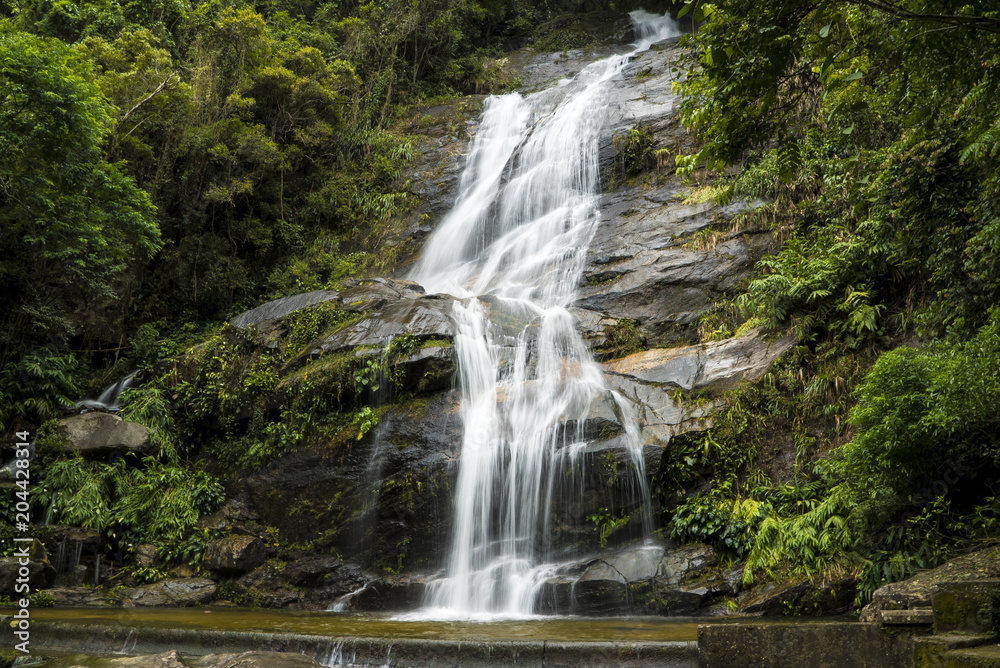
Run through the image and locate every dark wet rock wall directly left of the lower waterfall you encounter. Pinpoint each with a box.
[238,390,462,572]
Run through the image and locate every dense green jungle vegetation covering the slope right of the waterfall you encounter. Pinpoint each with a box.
[666,0,1000,600]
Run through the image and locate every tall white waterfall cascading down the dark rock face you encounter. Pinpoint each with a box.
[411,11,679,618]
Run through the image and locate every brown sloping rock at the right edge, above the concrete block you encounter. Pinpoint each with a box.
[861,546,1000,622]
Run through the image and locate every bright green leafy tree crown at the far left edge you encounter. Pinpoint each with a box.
[0,24,160,368]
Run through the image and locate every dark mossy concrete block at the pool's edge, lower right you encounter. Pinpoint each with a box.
[698,621,913,668]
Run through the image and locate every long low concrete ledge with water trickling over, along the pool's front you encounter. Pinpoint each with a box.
[25,622,698,668]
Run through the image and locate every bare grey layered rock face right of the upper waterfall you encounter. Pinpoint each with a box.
[577,40,772,345]
